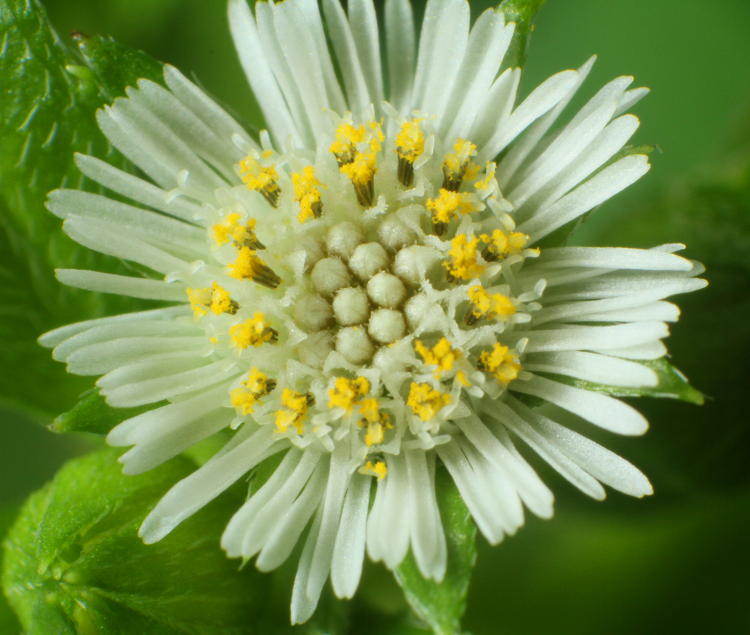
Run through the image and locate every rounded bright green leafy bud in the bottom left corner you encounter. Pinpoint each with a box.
[3,449,274,634]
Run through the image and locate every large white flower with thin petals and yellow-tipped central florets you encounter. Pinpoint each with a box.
[41,0,704,622]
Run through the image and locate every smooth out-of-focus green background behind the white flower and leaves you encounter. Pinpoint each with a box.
[5,0,750,635]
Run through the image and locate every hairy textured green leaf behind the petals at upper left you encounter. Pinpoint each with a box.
[0,0,165,421]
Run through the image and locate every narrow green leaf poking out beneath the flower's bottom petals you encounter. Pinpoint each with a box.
[394,469,476,635]
